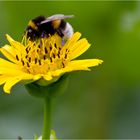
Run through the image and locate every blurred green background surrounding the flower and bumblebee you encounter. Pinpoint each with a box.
[0,1,140,139]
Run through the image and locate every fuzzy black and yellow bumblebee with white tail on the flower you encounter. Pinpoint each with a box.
[25,14,73,41]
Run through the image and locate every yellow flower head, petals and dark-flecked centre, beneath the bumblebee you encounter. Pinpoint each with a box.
[0,32,103,93]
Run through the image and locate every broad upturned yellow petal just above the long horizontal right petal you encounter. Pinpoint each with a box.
[69,38,90,60]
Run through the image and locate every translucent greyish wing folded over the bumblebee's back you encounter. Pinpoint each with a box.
[41,14,74,24]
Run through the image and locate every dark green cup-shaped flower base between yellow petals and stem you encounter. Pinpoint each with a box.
[25,74,69,98]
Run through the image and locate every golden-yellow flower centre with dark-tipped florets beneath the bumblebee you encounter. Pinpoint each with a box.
[16,34,69,74]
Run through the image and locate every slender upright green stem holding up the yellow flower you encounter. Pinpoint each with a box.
[42,97,51,140]
